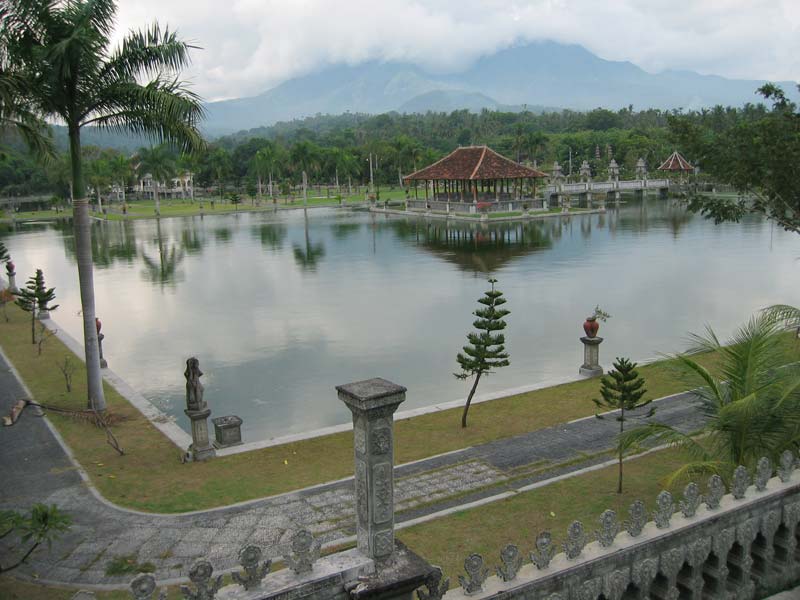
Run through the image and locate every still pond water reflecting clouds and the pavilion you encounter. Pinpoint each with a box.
[3,198,800,441]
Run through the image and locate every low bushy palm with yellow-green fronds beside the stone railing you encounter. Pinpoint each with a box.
[621,312,800,481]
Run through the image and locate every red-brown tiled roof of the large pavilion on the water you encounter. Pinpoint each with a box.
[403,146,547,181]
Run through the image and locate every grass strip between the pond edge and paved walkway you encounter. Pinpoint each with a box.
[0,305,798,512]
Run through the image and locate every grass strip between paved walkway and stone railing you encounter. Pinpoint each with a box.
[404,450,692,588]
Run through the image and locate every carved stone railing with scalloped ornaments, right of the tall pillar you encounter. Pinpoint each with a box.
[438,451,800,600]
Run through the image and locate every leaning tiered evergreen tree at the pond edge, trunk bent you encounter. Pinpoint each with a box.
[454,279,510,427]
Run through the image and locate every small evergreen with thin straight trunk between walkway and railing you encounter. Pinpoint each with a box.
[593,358,655,494]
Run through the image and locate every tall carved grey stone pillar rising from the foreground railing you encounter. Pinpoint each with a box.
[336,378,406,561]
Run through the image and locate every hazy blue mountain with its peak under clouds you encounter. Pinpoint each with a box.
[204,42,797,135]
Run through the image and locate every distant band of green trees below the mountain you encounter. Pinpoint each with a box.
[0,104,768,197]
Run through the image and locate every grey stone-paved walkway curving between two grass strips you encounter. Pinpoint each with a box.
[0,355,701,586]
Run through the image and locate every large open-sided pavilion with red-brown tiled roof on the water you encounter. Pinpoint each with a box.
[403,146,547,203]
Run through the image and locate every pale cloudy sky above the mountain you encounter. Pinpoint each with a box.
[119,0,800,99]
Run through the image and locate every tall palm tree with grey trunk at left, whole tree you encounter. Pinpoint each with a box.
[0,0,203,410]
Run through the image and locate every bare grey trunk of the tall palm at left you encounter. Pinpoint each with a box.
[69,125,106,411]
